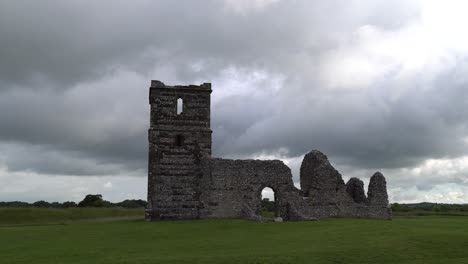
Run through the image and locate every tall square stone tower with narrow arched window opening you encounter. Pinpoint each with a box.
[145,80,212,220]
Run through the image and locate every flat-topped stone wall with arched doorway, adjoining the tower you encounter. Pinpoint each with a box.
[200,159,305,220]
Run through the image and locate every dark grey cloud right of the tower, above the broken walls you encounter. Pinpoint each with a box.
[219,66,468,168]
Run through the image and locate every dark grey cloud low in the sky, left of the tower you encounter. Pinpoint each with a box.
[0,74,148,175]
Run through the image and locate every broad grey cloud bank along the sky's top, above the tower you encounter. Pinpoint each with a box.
[0,0,415,88]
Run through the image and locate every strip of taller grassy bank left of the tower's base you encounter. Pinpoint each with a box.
[0,207,144,225]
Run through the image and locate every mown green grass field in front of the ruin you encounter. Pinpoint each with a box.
[0,209,468,264]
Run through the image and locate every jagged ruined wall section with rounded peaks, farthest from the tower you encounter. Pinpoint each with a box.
[300,150,391,219]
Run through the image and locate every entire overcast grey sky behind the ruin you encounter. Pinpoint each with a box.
[0,0,468,203]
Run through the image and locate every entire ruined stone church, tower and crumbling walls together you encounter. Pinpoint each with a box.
[145,81,391,221]
